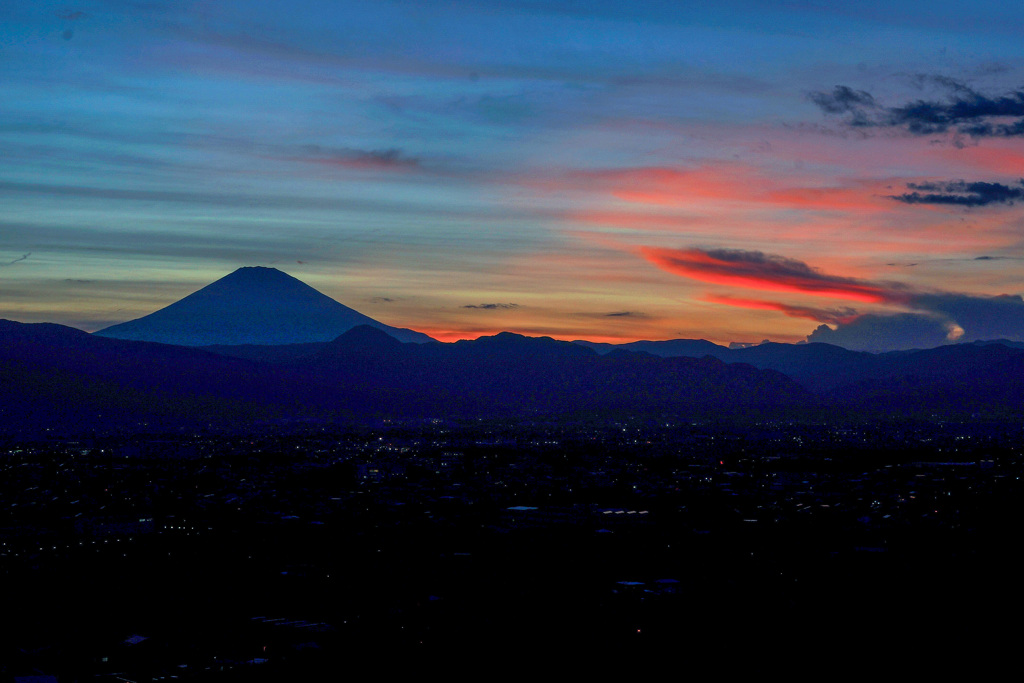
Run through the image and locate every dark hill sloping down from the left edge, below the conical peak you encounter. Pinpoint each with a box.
[0,321,319,431]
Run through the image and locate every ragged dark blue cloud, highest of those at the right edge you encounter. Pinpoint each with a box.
[808,81,1024,137]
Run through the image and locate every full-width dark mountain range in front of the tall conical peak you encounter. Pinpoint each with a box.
[0,321,1024,434]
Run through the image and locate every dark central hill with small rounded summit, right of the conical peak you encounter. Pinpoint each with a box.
[293,329,813,415]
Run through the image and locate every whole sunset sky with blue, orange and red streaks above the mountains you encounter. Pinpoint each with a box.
[0,0,1024,351]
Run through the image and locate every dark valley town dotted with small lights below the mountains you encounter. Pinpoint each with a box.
[0,422,1024,683]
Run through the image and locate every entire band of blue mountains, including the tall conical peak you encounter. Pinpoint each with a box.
[0,268,1024,431]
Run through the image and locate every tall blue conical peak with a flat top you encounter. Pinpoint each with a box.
[95,266,432,346]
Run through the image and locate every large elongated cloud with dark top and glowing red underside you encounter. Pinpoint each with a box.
[640,247,905,303]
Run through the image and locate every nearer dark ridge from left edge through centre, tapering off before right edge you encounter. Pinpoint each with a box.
[0,321,817,431]
